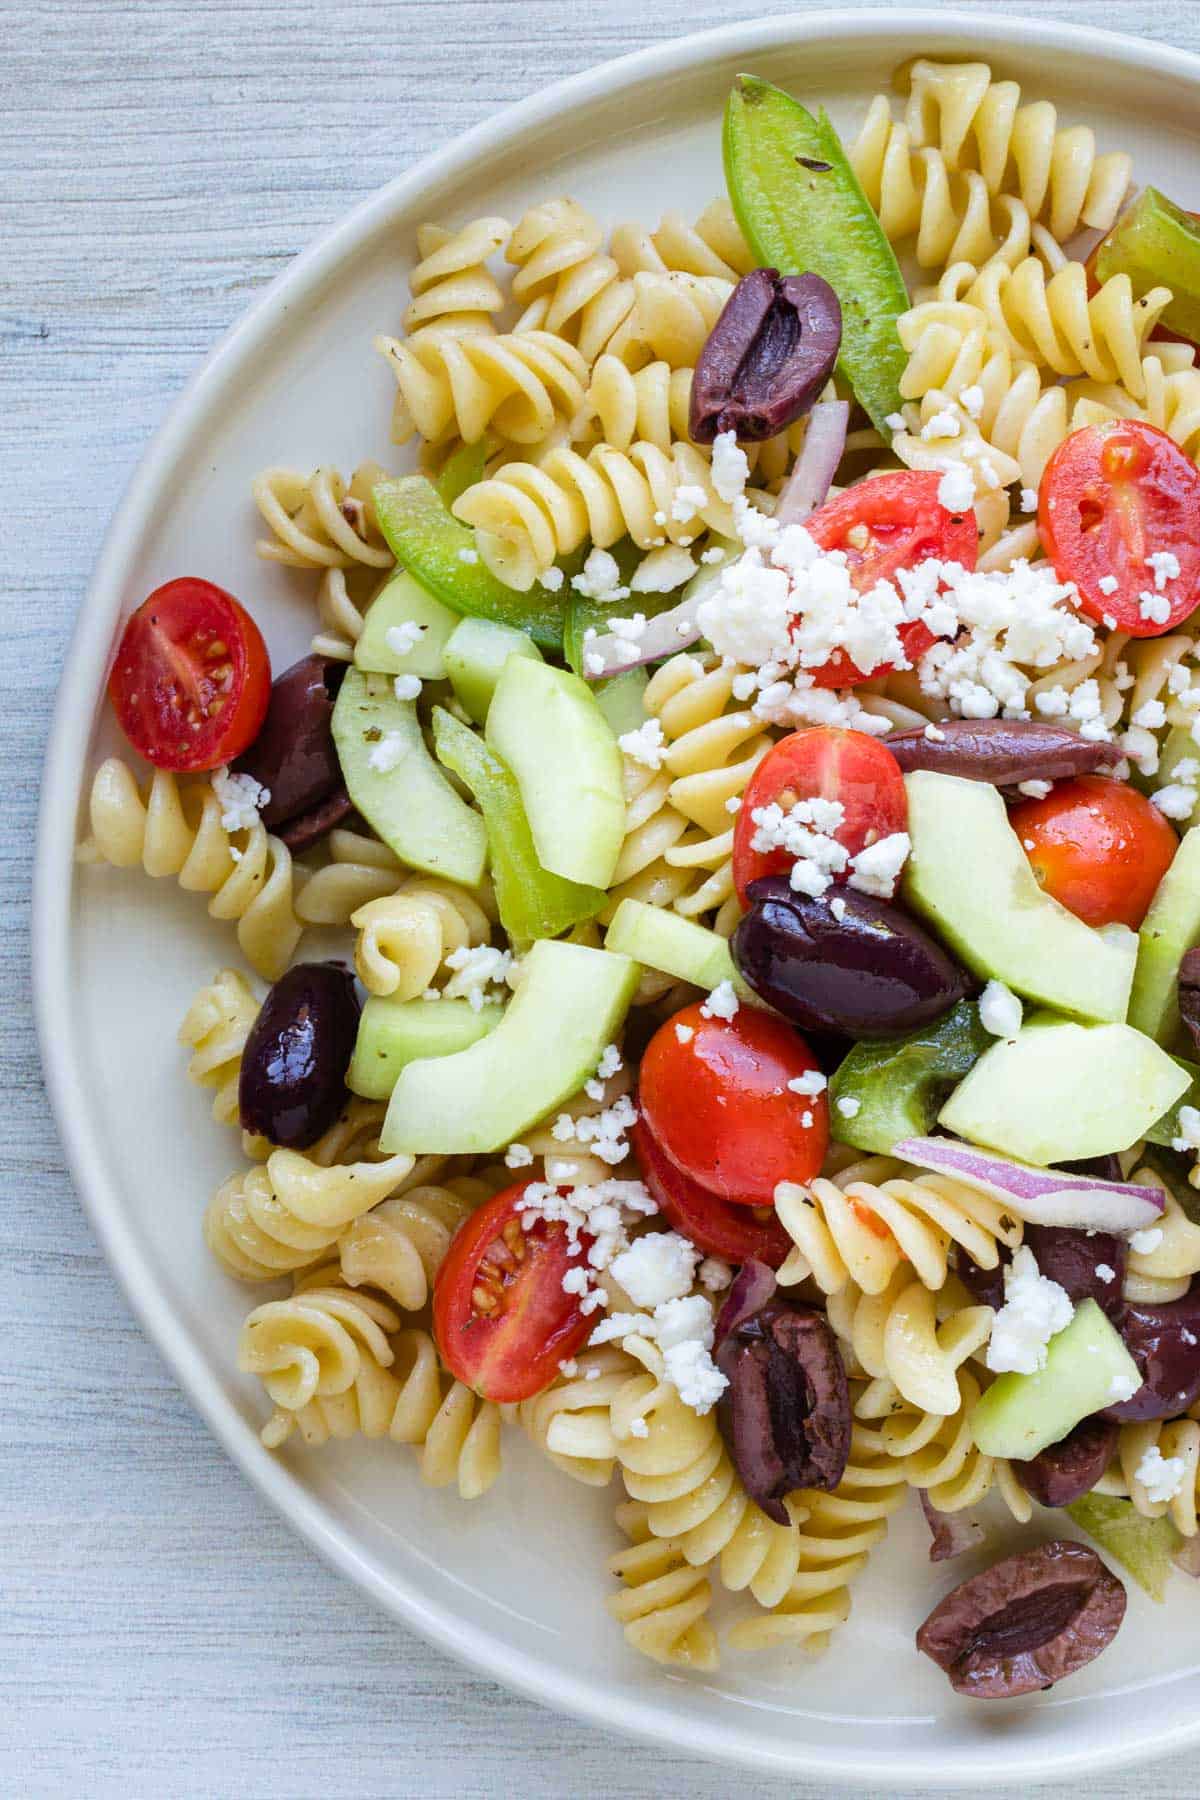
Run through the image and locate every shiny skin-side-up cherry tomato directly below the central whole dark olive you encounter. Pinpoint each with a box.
[639,1004,829,1206]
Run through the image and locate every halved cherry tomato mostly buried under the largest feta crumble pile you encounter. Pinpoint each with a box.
[804,468,979,688]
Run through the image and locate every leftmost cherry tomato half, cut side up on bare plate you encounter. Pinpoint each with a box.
[108,576,272,772]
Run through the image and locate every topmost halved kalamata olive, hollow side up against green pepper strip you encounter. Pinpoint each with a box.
[687,268,842,445]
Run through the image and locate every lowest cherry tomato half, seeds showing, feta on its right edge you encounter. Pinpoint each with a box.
[434,1181,594,1402]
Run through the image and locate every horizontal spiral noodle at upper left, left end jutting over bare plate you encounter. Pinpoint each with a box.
[374,329,588,445]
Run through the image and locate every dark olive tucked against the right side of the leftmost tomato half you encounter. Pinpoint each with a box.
[234,657,349,848]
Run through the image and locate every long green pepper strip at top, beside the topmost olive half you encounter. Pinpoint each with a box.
[723,76,909,443]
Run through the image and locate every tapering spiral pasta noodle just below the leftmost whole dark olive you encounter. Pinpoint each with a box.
[203,1150,414,1282]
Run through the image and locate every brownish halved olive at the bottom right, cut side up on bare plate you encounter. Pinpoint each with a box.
[918,1539,1124,1699]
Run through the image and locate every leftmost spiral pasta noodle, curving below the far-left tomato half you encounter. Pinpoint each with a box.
[79,756,300,981]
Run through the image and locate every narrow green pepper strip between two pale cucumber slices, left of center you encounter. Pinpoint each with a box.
[434,706,604,945]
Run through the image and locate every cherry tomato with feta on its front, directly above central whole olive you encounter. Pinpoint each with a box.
[734,725,909,905]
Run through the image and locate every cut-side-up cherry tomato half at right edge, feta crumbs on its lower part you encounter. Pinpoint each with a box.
[1038,419,1200,637]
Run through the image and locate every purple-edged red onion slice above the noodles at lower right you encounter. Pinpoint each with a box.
[892,1138,1166,1231]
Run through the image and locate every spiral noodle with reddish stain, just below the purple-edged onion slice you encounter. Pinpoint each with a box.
[775,1156,1022,1294]
